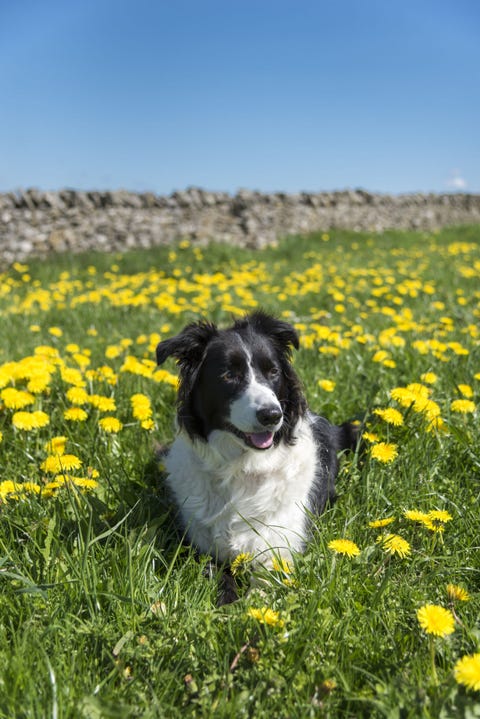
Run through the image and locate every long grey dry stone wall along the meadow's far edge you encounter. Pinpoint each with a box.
[0,188,480,267]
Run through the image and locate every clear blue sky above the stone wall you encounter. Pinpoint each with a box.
[0,0,480,194]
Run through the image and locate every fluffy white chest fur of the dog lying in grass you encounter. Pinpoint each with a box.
[165,416,316,565]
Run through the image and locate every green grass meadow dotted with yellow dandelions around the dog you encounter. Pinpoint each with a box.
[0,227,480,719]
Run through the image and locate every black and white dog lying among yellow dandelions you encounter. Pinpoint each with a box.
[157,312,356,580]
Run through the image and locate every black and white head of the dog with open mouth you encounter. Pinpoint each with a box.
[157,312,306,450]
